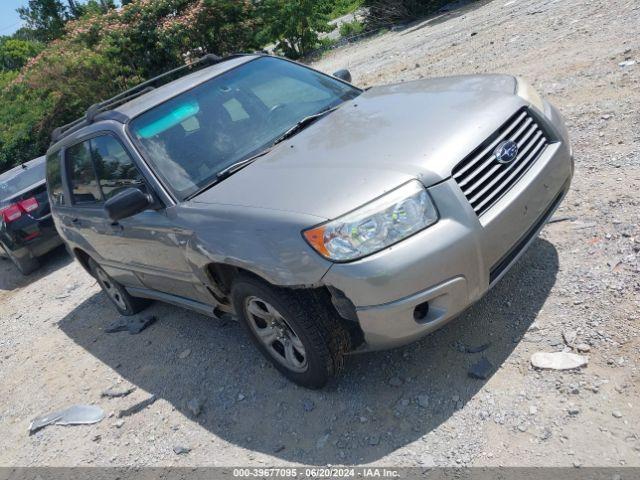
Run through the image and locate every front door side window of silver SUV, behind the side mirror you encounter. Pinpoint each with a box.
[91,135,146,200]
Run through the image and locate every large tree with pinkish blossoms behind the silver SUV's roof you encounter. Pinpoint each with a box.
[0,0,260,172]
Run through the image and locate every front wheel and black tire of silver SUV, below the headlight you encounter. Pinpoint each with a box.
[231,277,350,389]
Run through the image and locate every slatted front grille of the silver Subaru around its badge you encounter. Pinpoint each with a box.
[453,108,550,216]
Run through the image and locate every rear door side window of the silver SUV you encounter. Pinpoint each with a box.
[66,140,102,204]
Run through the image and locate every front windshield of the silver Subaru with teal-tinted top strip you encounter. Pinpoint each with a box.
[130,57,360,199]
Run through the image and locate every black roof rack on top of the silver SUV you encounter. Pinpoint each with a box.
[51,53,225,143]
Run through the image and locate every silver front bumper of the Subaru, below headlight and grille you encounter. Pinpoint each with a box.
[323,133,573,350]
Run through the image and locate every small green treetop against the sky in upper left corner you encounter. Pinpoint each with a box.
[16,0,68,42]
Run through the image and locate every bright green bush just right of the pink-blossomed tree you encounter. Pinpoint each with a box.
[259,0,334,58]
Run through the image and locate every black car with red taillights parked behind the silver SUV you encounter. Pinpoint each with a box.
[0,157,62,275]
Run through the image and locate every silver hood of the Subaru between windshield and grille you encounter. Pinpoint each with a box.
[193,75,523,219]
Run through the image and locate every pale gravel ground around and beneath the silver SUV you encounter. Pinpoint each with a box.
[0,0,640,466]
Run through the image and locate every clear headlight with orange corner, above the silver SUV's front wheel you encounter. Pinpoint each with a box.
[302,180,438,262]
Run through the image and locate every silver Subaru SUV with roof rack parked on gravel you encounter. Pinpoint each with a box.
[47,55,573,388]
